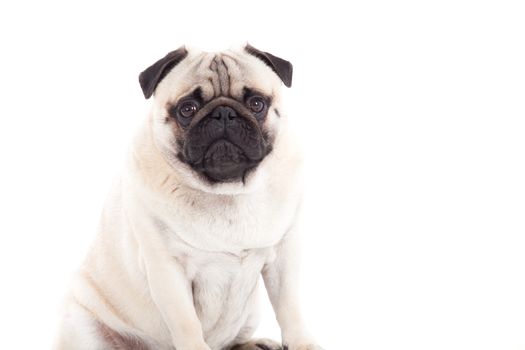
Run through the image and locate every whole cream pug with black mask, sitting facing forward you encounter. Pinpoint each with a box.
[54,44,321,350]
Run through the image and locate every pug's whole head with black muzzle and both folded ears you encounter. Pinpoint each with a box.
[140,45,292,193]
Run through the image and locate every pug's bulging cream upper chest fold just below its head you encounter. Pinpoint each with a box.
[164,187,298,255]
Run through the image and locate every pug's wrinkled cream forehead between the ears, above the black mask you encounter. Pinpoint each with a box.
[156,51,281,102]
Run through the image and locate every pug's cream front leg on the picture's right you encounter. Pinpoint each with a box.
[262,224,322,350]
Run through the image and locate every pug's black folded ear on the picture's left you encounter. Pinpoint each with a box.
[139,46,188,98]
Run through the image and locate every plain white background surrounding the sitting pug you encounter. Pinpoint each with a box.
[0,0,525,350]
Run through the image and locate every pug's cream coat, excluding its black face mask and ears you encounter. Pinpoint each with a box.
[54,49,320,350]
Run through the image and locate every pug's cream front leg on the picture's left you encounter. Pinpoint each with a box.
[130,213,210,350]
